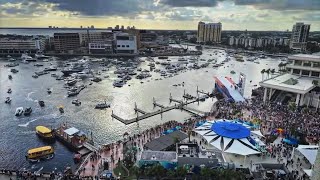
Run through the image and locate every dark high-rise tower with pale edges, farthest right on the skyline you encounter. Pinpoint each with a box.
[290,22,310,51]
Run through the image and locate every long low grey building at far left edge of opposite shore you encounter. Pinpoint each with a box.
[0,37,45,54]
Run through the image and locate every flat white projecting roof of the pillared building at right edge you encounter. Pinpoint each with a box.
[259,74,315,94]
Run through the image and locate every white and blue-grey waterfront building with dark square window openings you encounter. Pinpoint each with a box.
[114,32,138,54]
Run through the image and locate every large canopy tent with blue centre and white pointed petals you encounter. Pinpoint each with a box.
[195,119,261,156]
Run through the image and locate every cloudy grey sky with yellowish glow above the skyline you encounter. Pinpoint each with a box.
[0,0,320,31]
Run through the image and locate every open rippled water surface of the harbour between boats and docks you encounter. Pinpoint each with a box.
[0,49,279,171]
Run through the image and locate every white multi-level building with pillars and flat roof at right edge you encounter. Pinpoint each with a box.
[259,54,320,108]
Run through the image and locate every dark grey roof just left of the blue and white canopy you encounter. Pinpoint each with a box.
[144,131,188,151]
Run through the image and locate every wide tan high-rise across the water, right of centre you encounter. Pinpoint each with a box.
[197,22,222,43]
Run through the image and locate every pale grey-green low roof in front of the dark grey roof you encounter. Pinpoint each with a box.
[140,150,177,161]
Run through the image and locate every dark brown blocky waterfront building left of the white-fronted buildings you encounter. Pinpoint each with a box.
[53,33,80,53]
